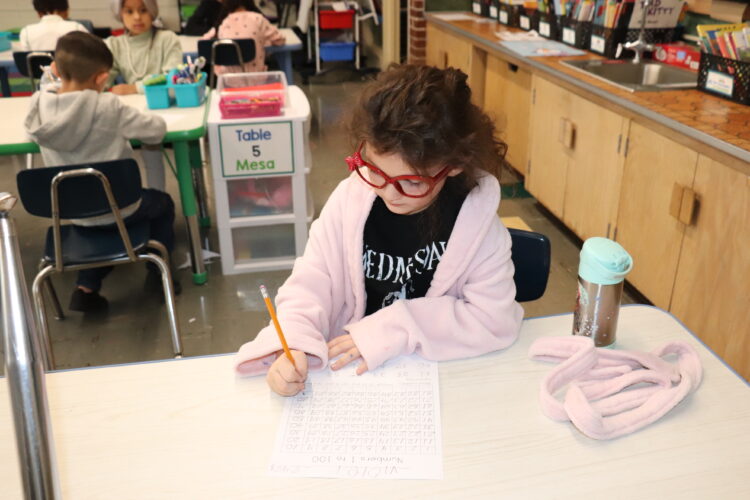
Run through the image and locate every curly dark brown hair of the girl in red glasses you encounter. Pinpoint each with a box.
[348,64,507,190]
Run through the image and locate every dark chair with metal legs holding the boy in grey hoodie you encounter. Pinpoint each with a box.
[17,159,182,369]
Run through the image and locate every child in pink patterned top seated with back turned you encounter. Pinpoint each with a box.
[203,0,285,75]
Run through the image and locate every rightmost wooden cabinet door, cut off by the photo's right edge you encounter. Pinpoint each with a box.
[672,156,750,380]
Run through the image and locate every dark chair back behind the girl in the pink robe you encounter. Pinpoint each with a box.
[508,228,551,302]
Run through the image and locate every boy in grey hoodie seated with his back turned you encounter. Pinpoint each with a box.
[24,32,179,312]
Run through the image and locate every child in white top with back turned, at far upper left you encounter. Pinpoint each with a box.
[18,0,86,51]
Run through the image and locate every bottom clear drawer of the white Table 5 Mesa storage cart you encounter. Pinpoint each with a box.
[232,224,296,264]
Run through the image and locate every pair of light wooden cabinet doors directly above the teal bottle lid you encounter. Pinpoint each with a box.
[526,76,628,239]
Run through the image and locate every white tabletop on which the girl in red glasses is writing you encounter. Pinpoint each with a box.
[0,305,750,500]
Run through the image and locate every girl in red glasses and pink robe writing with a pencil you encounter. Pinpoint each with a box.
[236,65,523,396]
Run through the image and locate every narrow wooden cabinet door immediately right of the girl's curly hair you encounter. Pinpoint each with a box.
[484,55,531,175]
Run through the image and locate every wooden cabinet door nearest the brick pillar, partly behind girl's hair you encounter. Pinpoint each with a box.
[425,25,487,106]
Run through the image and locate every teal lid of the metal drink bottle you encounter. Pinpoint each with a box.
[578,237,633,285]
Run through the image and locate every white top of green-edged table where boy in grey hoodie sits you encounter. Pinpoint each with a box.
[0,94,208,148]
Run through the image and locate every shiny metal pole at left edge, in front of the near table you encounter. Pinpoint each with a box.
[0,193,60,500]
